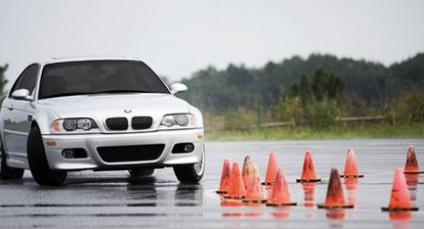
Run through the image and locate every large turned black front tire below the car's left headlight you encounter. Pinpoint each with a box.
[27,125,67,186]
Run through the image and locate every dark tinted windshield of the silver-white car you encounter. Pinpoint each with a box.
[38,60,170,99]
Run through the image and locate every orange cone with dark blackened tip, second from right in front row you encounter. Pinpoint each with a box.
[317,168,353,209]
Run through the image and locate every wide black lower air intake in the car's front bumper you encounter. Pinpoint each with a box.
[97,144,165,162]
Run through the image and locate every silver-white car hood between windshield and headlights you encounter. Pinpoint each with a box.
[39,94,189,119]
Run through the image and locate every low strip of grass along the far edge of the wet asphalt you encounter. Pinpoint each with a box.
[206,123,424,141]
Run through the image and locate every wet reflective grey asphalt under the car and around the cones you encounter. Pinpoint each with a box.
[0,139,424,229]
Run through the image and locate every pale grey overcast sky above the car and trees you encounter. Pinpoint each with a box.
[0,0,424,87]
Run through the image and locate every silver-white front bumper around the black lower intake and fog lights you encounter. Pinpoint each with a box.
[43,129,204,170]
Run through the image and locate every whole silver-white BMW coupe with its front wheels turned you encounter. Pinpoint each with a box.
[0,58,205,185]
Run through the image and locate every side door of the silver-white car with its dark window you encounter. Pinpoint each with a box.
[1,64,39,168]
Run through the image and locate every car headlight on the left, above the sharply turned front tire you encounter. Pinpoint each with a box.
[50,118,98,133]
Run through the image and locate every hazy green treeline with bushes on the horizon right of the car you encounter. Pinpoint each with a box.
[177,53,424,129]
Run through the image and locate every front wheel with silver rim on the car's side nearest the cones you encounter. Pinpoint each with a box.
[174,151,205,184]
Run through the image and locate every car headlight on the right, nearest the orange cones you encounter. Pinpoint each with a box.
[159,114,197,129]
